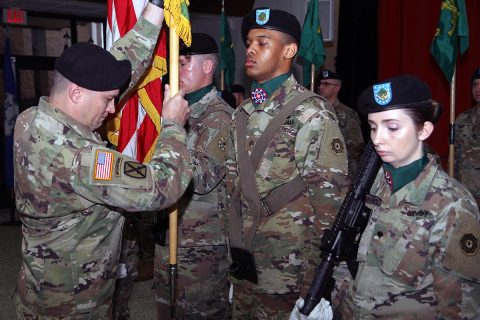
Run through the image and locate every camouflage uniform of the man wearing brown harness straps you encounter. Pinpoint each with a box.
[227,76,347,319]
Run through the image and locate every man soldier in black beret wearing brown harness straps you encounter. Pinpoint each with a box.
[227,8,348,320]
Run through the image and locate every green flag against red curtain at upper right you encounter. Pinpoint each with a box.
[430,0,468,82]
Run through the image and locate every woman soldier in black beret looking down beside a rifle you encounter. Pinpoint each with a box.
[336,75,480,319]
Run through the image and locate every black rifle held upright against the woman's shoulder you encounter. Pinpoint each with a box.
[300,141,382,315]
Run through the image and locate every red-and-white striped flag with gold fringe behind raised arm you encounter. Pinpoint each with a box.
[107,0,167,162]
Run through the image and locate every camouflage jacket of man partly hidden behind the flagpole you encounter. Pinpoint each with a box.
[171,88,233,247]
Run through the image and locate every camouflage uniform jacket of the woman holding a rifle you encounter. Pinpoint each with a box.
[338,155,480,319]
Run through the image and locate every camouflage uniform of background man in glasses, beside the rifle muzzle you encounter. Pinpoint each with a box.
[332,100,365,180]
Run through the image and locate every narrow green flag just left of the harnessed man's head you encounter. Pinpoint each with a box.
[220,7,235,86]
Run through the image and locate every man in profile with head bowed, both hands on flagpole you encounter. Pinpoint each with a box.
[13,1,192,319]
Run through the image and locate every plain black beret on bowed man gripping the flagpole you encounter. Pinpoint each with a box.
[55,42,132,91]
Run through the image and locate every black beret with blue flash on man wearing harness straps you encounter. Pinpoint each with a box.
[242,8,302,43]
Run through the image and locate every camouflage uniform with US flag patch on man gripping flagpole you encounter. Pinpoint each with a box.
[14,18,191,319]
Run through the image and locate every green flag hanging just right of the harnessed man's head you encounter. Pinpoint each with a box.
[298,0,325,86]
